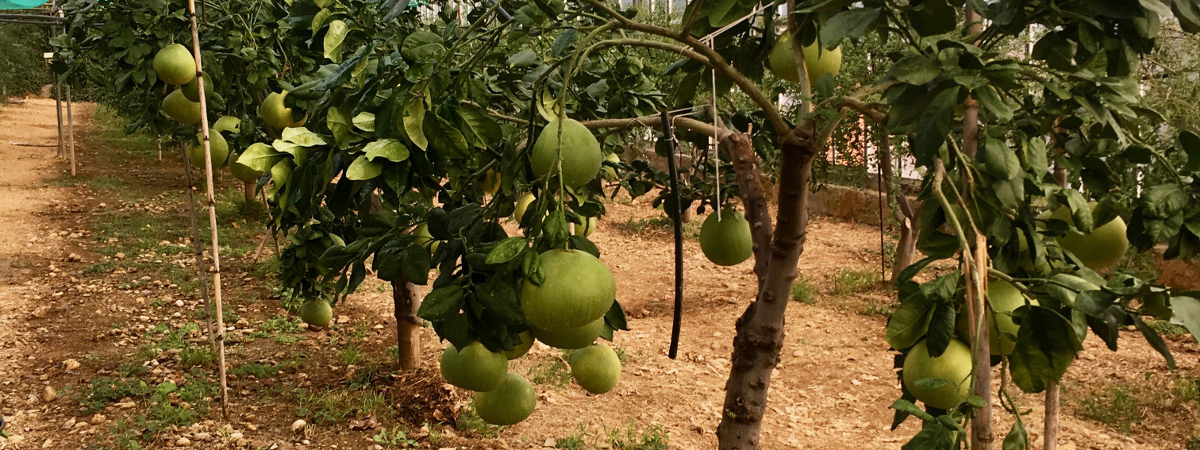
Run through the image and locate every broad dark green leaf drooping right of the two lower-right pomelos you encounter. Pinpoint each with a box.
[1009,306,1082,392]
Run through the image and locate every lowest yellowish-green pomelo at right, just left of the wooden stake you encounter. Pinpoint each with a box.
[904,338,974,409]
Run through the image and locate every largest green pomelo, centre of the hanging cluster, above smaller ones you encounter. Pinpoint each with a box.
[521,250,617,331]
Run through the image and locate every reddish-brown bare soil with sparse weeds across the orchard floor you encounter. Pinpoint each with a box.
[0,100,1200,450]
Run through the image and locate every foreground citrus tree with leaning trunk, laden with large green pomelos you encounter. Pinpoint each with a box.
[56,0,1200,449]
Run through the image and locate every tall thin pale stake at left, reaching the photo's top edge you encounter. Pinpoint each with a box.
[187,0,229,414]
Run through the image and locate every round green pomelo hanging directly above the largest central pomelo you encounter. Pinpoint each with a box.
[529,119,604,187]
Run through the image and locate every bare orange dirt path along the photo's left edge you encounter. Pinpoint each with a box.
[0,98,91,446]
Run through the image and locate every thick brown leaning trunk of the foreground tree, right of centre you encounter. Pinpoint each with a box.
[716,136,814,450]
